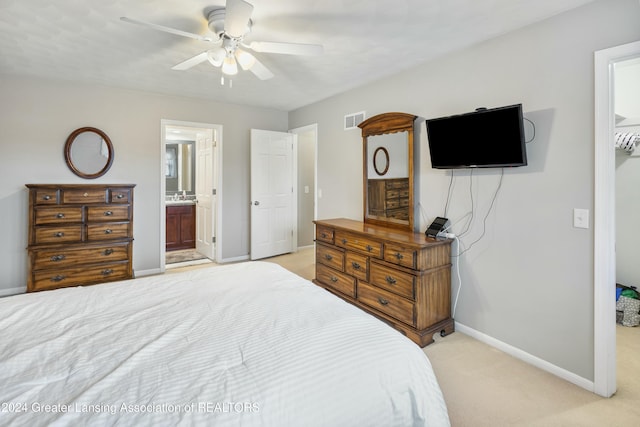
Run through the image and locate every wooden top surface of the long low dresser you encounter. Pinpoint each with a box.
[313,218,452,247]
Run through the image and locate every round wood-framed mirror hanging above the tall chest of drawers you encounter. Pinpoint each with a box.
[64,127,113,179]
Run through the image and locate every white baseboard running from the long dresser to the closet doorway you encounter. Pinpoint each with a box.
[455,322,595,393]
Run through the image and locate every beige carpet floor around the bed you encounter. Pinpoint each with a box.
[166,247,640,427]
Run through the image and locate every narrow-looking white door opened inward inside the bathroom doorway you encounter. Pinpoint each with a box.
[196,129,217,259]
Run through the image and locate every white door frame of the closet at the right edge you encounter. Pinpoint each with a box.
[593,41,640,397]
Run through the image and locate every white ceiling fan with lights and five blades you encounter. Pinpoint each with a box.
[120,0,323,80]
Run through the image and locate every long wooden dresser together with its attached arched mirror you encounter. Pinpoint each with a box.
[314,113,454,347]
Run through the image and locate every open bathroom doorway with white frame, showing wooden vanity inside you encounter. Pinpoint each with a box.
[160,120,222,271]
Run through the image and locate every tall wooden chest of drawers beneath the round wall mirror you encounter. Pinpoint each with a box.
[27,184,135,292]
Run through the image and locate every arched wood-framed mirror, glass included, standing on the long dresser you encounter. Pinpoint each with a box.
[358,113,416,230]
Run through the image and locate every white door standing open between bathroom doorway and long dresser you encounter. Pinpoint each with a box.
[251,129,296,259]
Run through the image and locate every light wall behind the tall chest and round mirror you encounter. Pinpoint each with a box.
[0,76,288,292]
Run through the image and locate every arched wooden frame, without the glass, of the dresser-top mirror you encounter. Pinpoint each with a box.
[358,112,417,231]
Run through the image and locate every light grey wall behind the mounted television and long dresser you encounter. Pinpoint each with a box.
[289,0,640,381]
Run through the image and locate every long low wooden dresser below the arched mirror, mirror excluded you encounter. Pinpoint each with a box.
[314,219,454,347]
